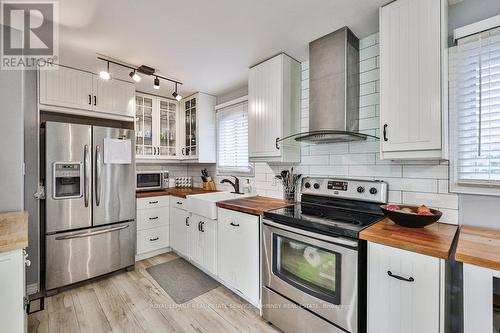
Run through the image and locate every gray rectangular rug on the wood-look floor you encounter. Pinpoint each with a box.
[146,258,220,304]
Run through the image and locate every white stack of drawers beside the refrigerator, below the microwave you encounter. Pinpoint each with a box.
[136,196,170,260]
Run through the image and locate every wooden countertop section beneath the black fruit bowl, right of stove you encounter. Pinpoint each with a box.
[359,218,458,259]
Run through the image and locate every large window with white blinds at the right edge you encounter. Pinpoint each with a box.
[450,28,500,195]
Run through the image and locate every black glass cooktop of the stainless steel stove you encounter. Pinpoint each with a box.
[264,197,384,238]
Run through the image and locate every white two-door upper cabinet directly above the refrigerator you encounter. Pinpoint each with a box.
[38,65,135,117]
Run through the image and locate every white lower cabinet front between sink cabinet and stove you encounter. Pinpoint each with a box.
[217,208,260,306]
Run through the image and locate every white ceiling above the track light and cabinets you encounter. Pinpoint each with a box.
[59,0,387,95]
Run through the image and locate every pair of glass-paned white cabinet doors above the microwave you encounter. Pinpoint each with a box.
[135,93,179,159]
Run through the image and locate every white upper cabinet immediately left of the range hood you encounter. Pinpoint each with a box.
[248,54,300,162]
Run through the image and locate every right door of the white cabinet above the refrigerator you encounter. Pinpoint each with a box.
[92,75,135,117]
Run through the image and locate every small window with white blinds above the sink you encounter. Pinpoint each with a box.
[217,102,253,175]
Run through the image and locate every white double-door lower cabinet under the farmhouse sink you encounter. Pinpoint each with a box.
[188,214,217,276]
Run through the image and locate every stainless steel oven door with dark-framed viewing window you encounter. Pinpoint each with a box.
[263,220,358,332]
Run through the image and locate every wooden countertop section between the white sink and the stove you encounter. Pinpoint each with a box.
[217,196,294,215]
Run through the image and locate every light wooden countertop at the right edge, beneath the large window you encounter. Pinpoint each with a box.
[455,225,500,270]
